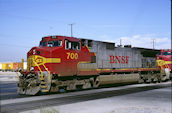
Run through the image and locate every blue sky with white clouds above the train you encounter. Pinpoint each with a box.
[0,0,171,62]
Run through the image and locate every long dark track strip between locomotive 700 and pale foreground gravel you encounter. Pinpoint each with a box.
[1,82,171,113]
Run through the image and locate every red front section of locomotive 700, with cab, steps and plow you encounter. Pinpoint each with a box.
[18,36,93,95]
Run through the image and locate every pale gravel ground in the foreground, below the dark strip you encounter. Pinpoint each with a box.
[23,87,172,113]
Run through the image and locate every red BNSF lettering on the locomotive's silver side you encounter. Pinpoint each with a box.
[109,55,129,64]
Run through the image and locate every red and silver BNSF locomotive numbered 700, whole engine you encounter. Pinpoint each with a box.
[18,36,169,95]
